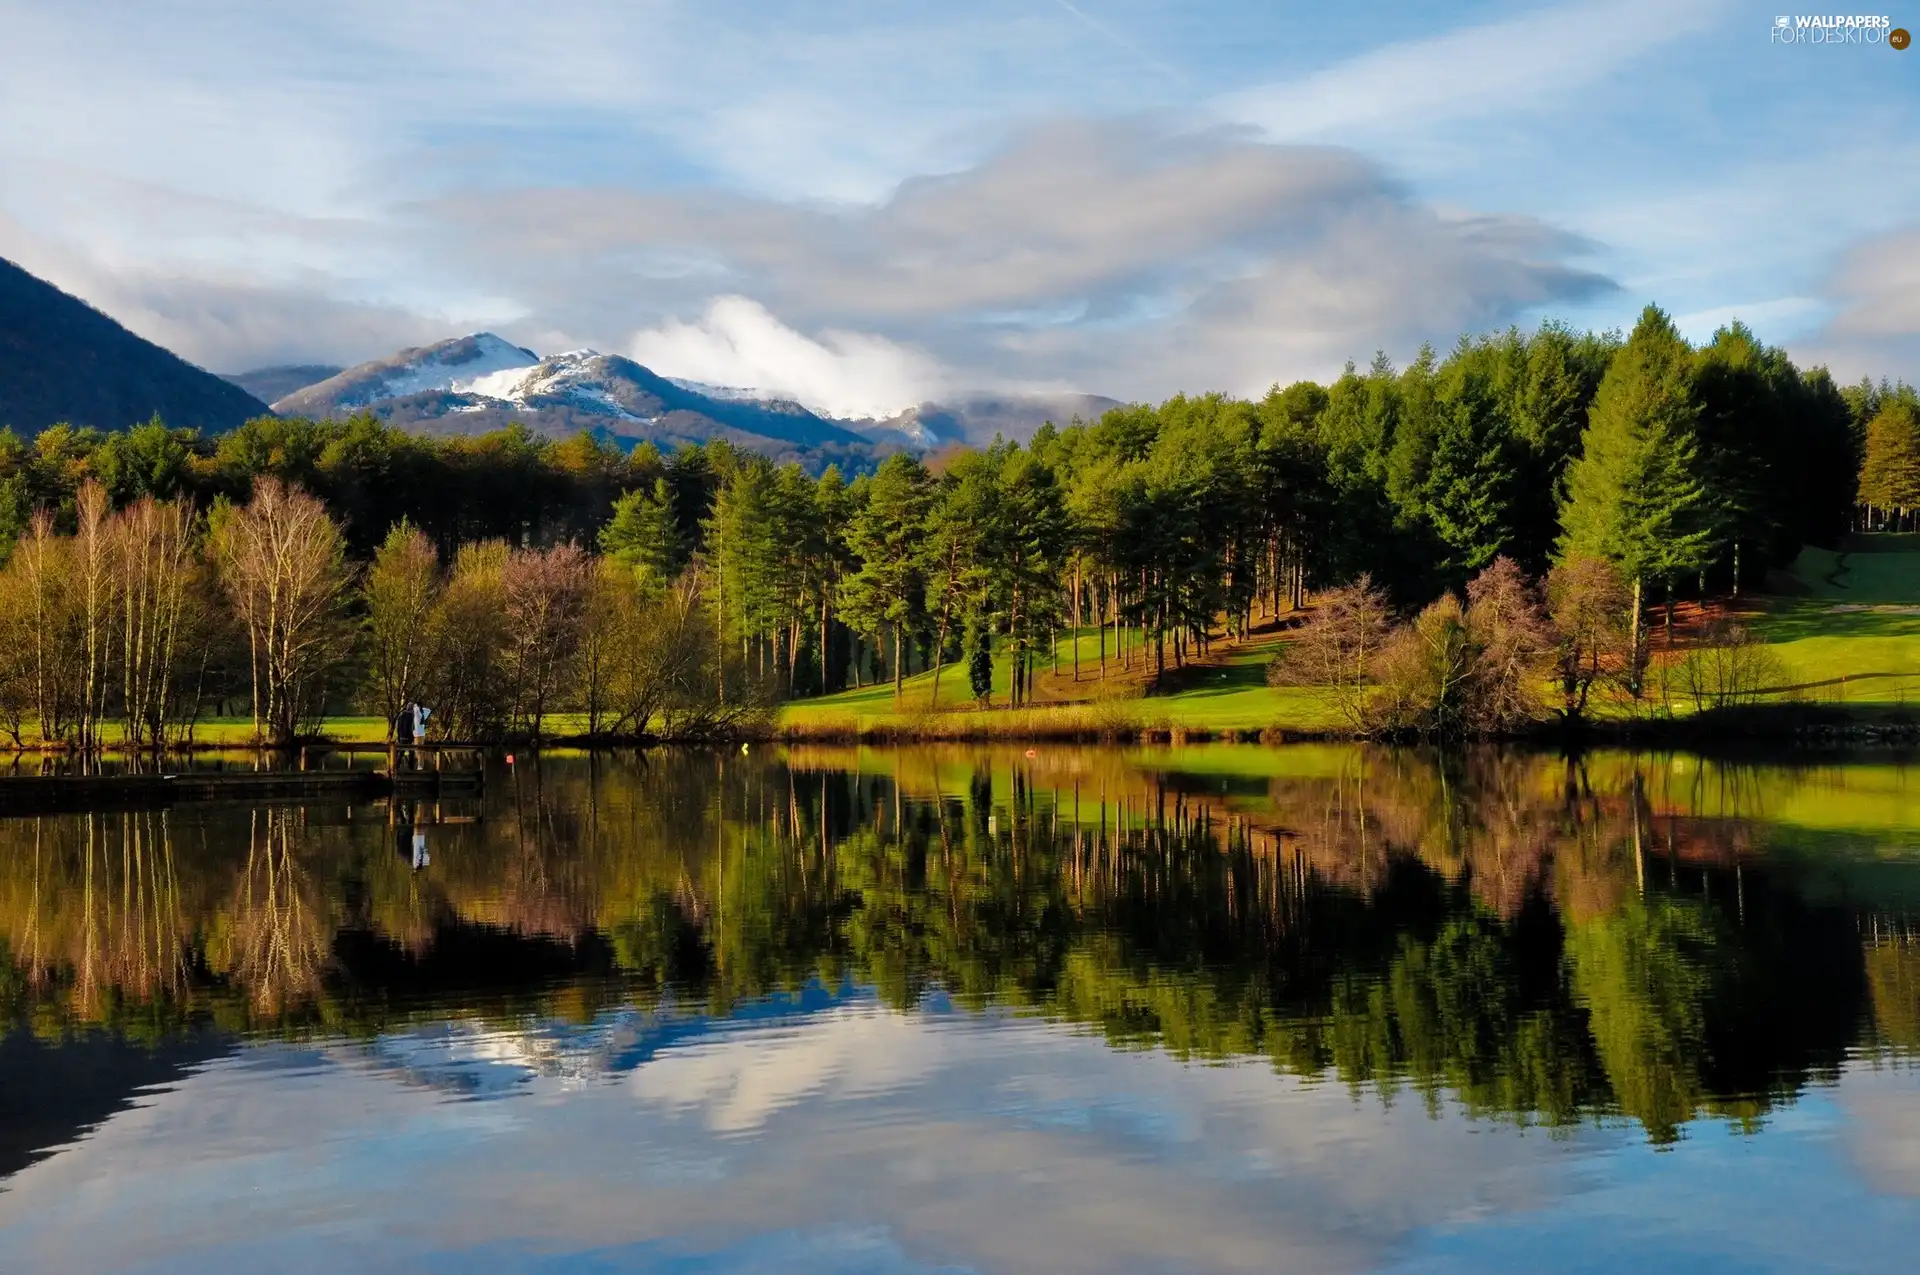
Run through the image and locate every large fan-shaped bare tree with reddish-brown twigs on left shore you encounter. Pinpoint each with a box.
[211,478,351,743]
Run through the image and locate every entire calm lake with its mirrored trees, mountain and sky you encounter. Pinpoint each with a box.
[0,745,1920,1273]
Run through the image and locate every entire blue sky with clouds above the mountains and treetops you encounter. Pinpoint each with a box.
[0,0,1920,415]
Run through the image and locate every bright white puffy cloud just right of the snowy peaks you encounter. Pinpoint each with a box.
[630,296,945,417]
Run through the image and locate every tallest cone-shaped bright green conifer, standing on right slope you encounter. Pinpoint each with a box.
[1559,305,1715,687]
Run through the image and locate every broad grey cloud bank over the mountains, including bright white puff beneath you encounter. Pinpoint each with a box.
[441,119,1611,399]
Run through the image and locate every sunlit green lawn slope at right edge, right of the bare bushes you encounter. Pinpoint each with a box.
[1755,536,1920,707]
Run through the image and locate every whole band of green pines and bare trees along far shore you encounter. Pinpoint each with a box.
[0,307,1920,749]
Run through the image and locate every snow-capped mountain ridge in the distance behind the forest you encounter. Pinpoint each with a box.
[273,332,872,457]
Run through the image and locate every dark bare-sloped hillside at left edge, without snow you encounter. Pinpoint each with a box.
[0,259,267,434]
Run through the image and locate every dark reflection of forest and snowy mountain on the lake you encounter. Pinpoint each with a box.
[0,749,1920,1144]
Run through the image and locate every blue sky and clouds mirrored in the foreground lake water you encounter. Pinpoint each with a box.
[0,998,1920,1275]
